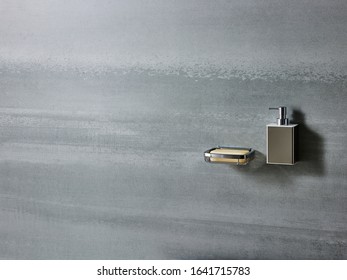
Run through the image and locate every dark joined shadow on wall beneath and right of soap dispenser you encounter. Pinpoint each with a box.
[231,109,325,184]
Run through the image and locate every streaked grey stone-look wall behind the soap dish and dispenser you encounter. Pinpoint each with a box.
[0,0,347,259]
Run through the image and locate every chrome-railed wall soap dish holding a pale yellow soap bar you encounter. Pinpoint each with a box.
[204,146,255,165]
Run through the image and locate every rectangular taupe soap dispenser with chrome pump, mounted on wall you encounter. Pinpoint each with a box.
[266,107,298,165]
